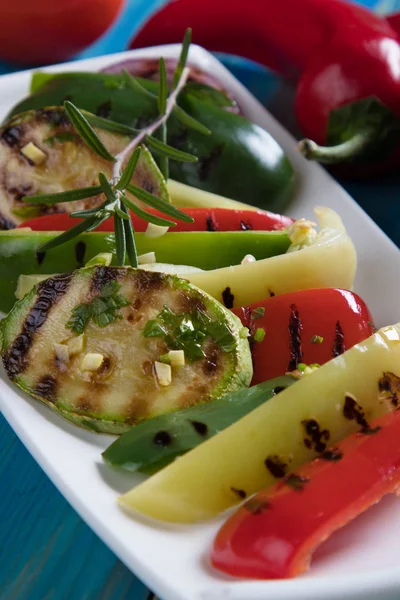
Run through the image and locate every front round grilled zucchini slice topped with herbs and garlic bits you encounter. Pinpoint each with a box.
[1,267,252,434]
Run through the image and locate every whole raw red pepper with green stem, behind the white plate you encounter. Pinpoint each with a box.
[132,0,400,176]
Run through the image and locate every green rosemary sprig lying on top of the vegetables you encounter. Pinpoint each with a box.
[23,30,210,267]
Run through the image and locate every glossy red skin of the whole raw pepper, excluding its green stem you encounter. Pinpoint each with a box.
[131,0,400,175]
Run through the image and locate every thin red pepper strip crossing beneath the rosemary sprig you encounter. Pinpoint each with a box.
[19,208,293,232]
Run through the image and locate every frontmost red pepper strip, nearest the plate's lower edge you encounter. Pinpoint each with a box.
[211,410,400,579]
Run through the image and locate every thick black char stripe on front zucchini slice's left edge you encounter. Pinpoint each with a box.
[3,273,73,379]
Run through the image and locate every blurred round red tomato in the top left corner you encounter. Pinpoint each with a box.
[0,0,124,65]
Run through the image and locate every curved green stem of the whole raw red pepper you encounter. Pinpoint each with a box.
[297,127,379,165]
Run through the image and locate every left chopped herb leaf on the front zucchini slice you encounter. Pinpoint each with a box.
[66,281,130,334]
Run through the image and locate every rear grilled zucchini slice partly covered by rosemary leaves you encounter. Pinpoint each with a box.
[0,107,169,229]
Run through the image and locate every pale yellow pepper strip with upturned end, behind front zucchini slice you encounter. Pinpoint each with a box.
[185,207,357,308]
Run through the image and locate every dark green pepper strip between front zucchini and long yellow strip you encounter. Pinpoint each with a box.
[102,376,296,473]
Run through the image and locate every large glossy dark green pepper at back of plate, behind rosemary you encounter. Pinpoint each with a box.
[7,73,294,213]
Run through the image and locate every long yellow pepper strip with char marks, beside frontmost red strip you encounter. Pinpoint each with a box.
[120,323,400,523]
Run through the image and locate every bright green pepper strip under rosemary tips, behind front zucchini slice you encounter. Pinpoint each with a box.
[0,229,290,312]
